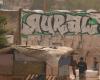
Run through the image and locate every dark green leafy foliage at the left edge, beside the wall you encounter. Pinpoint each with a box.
[0,16,7,48]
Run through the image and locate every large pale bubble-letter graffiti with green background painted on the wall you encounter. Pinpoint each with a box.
[22,12,100,35]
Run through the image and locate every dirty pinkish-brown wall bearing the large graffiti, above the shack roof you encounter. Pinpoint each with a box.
[21,11,100,52]
